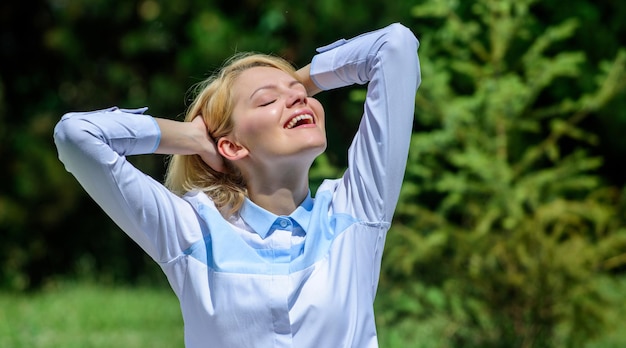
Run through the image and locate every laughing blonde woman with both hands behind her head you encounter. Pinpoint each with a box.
[54,24,420,347]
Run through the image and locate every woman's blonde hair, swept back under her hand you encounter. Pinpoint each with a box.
[165,53,298,215]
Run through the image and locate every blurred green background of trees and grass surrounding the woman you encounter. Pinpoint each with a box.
[0,0,626,347]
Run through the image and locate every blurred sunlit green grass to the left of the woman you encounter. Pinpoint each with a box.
[0,283,183,348]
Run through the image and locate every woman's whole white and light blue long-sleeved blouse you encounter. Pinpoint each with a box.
[54,24,420,348]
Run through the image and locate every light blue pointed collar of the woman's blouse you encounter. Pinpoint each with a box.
[239,191,313,239]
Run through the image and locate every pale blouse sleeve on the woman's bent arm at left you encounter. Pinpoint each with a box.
[54,107,201,263]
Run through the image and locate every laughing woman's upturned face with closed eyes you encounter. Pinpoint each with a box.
[231,67,326,165]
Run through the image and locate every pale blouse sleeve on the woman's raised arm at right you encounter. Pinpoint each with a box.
[311,23,421,223]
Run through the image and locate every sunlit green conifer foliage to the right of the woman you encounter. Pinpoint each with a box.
[379,0,626,347]
